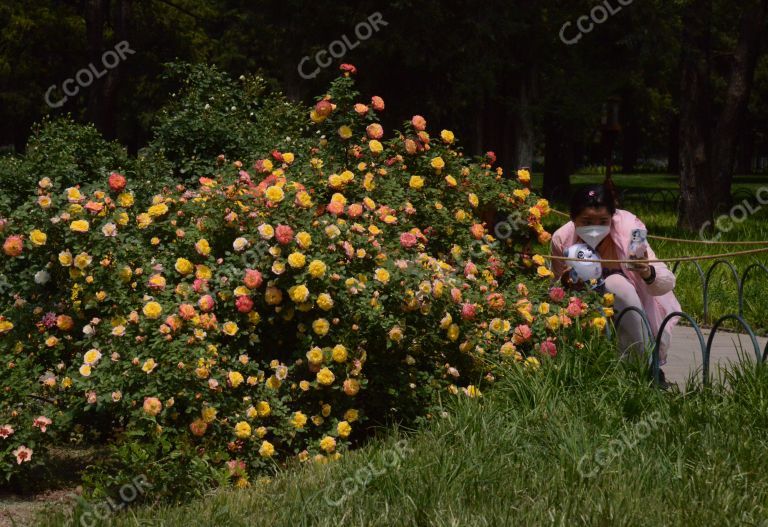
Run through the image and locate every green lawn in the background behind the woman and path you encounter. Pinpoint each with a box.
[534,174,768,334]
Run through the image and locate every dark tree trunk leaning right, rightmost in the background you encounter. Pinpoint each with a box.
[712,0,768,207]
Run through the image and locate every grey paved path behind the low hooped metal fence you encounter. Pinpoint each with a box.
[663,326,768,388]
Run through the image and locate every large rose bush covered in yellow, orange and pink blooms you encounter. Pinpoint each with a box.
[0,68,610,496]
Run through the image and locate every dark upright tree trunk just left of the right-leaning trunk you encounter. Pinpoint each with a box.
[677,0,714,231]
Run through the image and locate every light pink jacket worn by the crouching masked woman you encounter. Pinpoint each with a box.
[552,210,681,364]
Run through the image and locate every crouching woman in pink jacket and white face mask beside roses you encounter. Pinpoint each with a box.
[552,185,680,374]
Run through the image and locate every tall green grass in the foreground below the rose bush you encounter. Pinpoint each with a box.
[39,345,768,527]
